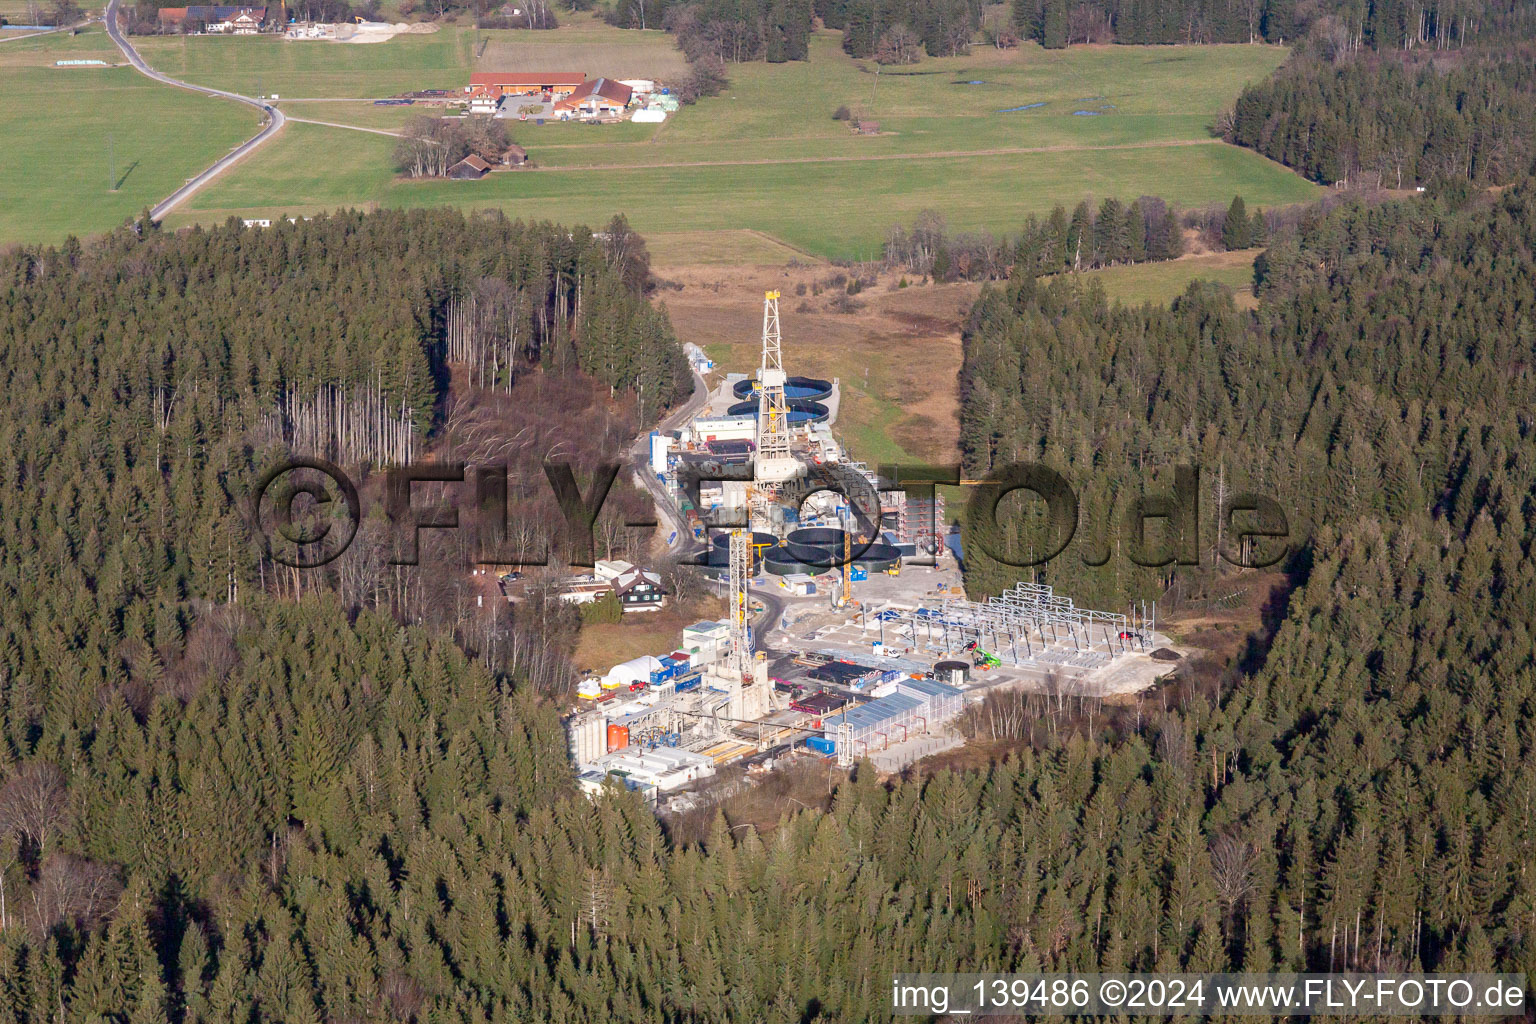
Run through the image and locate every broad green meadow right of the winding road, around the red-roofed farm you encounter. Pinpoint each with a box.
[162,21,1316,261]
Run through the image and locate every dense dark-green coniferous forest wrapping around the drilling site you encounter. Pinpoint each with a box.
[0,184,1536,1022]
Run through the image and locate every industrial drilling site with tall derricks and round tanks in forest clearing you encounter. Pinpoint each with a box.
[567,292,1172,809]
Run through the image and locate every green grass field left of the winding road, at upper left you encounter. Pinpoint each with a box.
[0,26,258,243]
